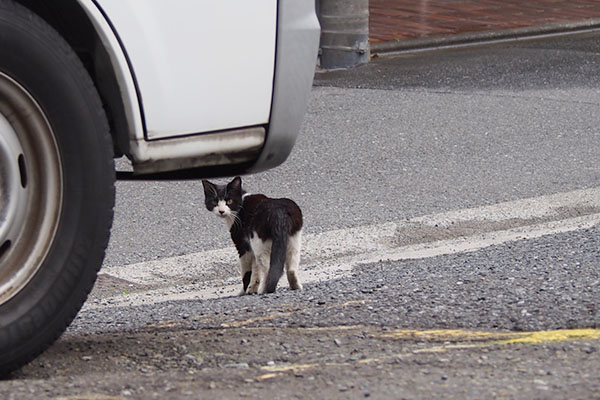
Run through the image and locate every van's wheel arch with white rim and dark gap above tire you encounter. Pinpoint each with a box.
[14,0,143,156]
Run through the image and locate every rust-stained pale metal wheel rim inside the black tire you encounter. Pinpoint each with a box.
[0,72,63,305]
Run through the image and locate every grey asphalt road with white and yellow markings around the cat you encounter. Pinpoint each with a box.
[0,33,600,399]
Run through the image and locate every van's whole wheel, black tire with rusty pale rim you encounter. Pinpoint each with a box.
[0,0,114,376]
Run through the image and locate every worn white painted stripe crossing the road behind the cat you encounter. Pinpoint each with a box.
[88,188,600,307]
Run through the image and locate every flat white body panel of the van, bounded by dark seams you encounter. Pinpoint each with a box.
[96,0,277,140]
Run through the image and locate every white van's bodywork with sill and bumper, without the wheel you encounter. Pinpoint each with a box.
[77,0,319,176]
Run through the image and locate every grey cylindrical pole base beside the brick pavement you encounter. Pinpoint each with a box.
[317,0,370,69]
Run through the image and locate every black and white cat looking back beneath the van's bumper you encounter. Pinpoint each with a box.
[202,176,302,295]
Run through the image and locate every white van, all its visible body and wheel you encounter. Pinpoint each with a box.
[0,0,319,376]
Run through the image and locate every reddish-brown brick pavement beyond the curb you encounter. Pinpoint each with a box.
[369,0,600,43]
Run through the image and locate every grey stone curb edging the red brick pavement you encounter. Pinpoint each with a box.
[371,18,600,57]
